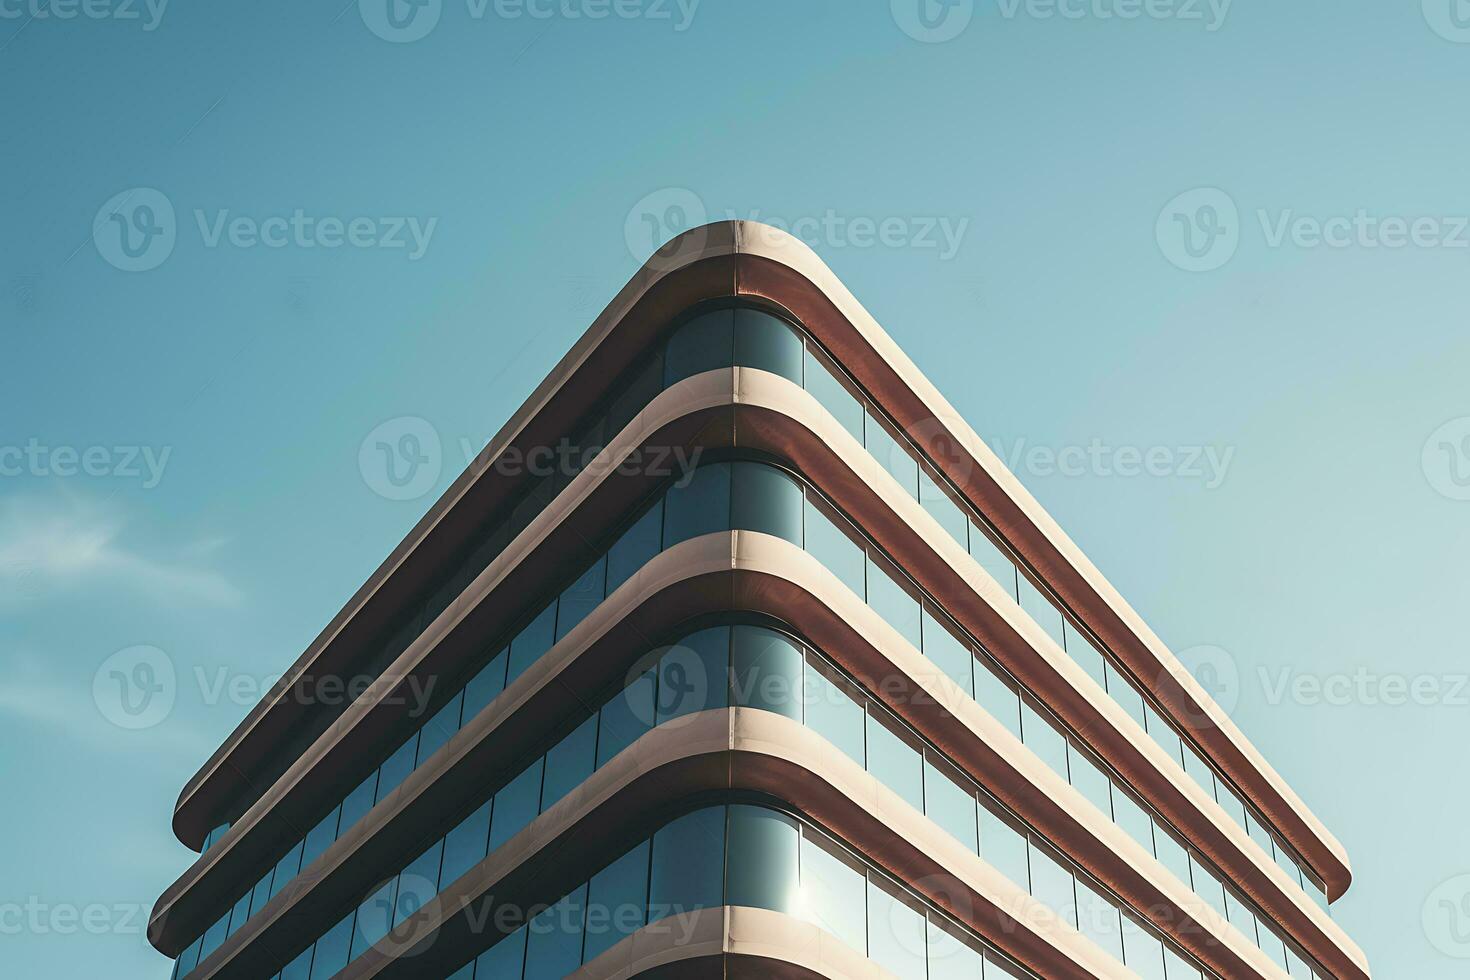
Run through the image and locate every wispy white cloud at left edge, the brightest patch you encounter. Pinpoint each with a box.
[0,494,244,605]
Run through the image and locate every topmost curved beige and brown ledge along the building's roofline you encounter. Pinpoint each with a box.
[175,222,1351,896]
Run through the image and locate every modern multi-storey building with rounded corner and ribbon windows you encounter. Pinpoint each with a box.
[148,222,1369,980]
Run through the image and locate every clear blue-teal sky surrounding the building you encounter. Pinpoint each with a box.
[0,0,1470,979]
